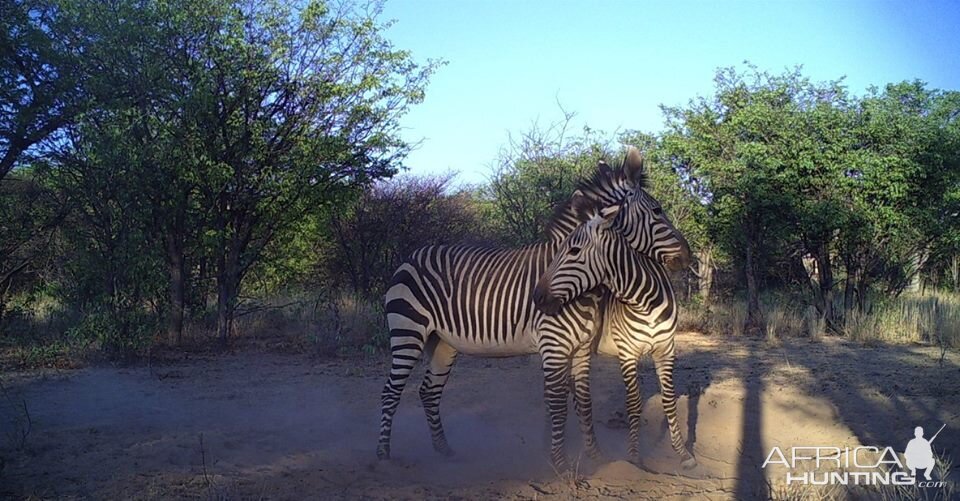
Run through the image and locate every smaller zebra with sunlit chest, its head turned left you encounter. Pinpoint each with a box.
[533,198,697,469]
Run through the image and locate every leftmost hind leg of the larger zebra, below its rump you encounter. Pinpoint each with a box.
[377,325,427,459]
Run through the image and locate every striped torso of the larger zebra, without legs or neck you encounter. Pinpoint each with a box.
[386,243,581,357]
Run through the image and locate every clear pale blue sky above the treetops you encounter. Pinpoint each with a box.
[383,0,960,183]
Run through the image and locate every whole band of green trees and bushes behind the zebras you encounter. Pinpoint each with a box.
[0,6,960,360]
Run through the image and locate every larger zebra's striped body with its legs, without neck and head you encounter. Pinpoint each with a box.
[378,242,600,467]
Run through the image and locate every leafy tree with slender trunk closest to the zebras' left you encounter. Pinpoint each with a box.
[171,2,436,341]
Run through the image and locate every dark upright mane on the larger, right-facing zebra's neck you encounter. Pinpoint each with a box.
[544,154,648,238]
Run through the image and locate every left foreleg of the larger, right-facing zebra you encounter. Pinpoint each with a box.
[540,345,570,471]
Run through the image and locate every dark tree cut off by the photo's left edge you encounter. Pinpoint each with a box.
[0,0,87,319]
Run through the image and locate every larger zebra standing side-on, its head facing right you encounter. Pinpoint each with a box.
[377,148,690,469]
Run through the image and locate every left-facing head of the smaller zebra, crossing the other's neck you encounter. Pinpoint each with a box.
[533,195,634,315]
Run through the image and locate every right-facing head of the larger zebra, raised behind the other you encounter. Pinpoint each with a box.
[614,146,691,271]
